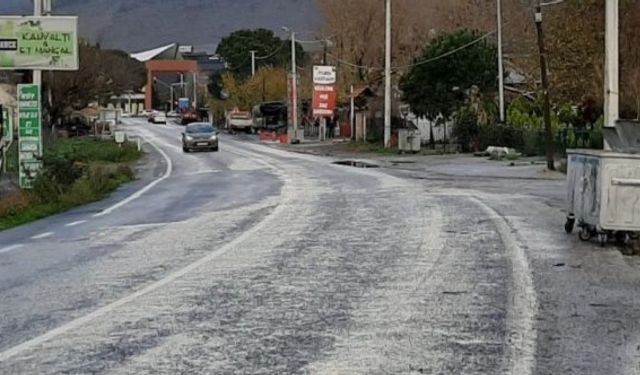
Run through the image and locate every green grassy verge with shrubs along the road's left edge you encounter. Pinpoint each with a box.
[0,138,143,230]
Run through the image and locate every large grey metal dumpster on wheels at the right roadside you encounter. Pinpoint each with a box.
[565,120,640,246]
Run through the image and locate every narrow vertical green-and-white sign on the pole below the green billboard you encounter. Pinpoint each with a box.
[18,84,42,189]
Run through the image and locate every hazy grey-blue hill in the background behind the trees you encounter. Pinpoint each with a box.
[0,0,321,52]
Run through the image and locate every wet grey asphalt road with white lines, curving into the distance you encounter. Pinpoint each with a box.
[0,120,640,375]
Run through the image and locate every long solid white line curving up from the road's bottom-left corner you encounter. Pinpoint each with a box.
[0,153,294,363]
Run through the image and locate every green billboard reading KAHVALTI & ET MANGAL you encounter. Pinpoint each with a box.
[0,16,78,70]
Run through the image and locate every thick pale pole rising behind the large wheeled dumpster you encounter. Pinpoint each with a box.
[604,0,620,150]
